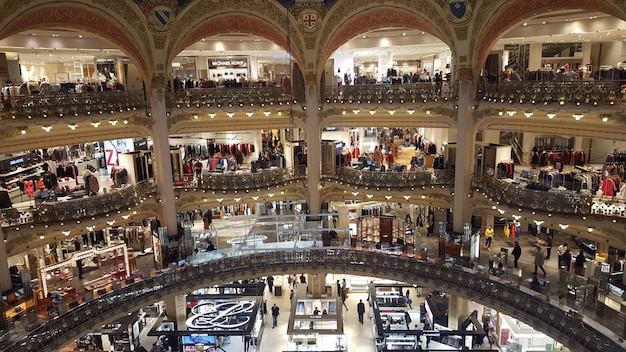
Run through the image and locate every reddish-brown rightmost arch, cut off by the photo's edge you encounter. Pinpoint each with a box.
[470,0,626,75]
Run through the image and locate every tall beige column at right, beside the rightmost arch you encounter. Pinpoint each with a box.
[452,67,476,233]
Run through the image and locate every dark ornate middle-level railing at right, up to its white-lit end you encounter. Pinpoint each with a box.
[472,176,593,215]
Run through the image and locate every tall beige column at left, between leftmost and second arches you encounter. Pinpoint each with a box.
[148,75,177,235]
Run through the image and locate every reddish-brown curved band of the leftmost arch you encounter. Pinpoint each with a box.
[0,2,150,77]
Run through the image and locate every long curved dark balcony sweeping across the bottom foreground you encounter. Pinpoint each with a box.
[5,247,623,352]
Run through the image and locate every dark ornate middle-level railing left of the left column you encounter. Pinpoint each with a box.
[0,180,156,226]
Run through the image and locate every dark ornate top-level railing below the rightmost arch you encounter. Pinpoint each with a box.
[477,81,626,106]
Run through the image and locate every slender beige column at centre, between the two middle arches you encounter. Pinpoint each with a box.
[305,86,322,214]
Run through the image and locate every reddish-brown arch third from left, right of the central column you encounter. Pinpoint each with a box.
[317,4,455,75]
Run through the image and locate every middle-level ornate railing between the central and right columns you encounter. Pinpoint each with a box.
[324,167,454,189]
